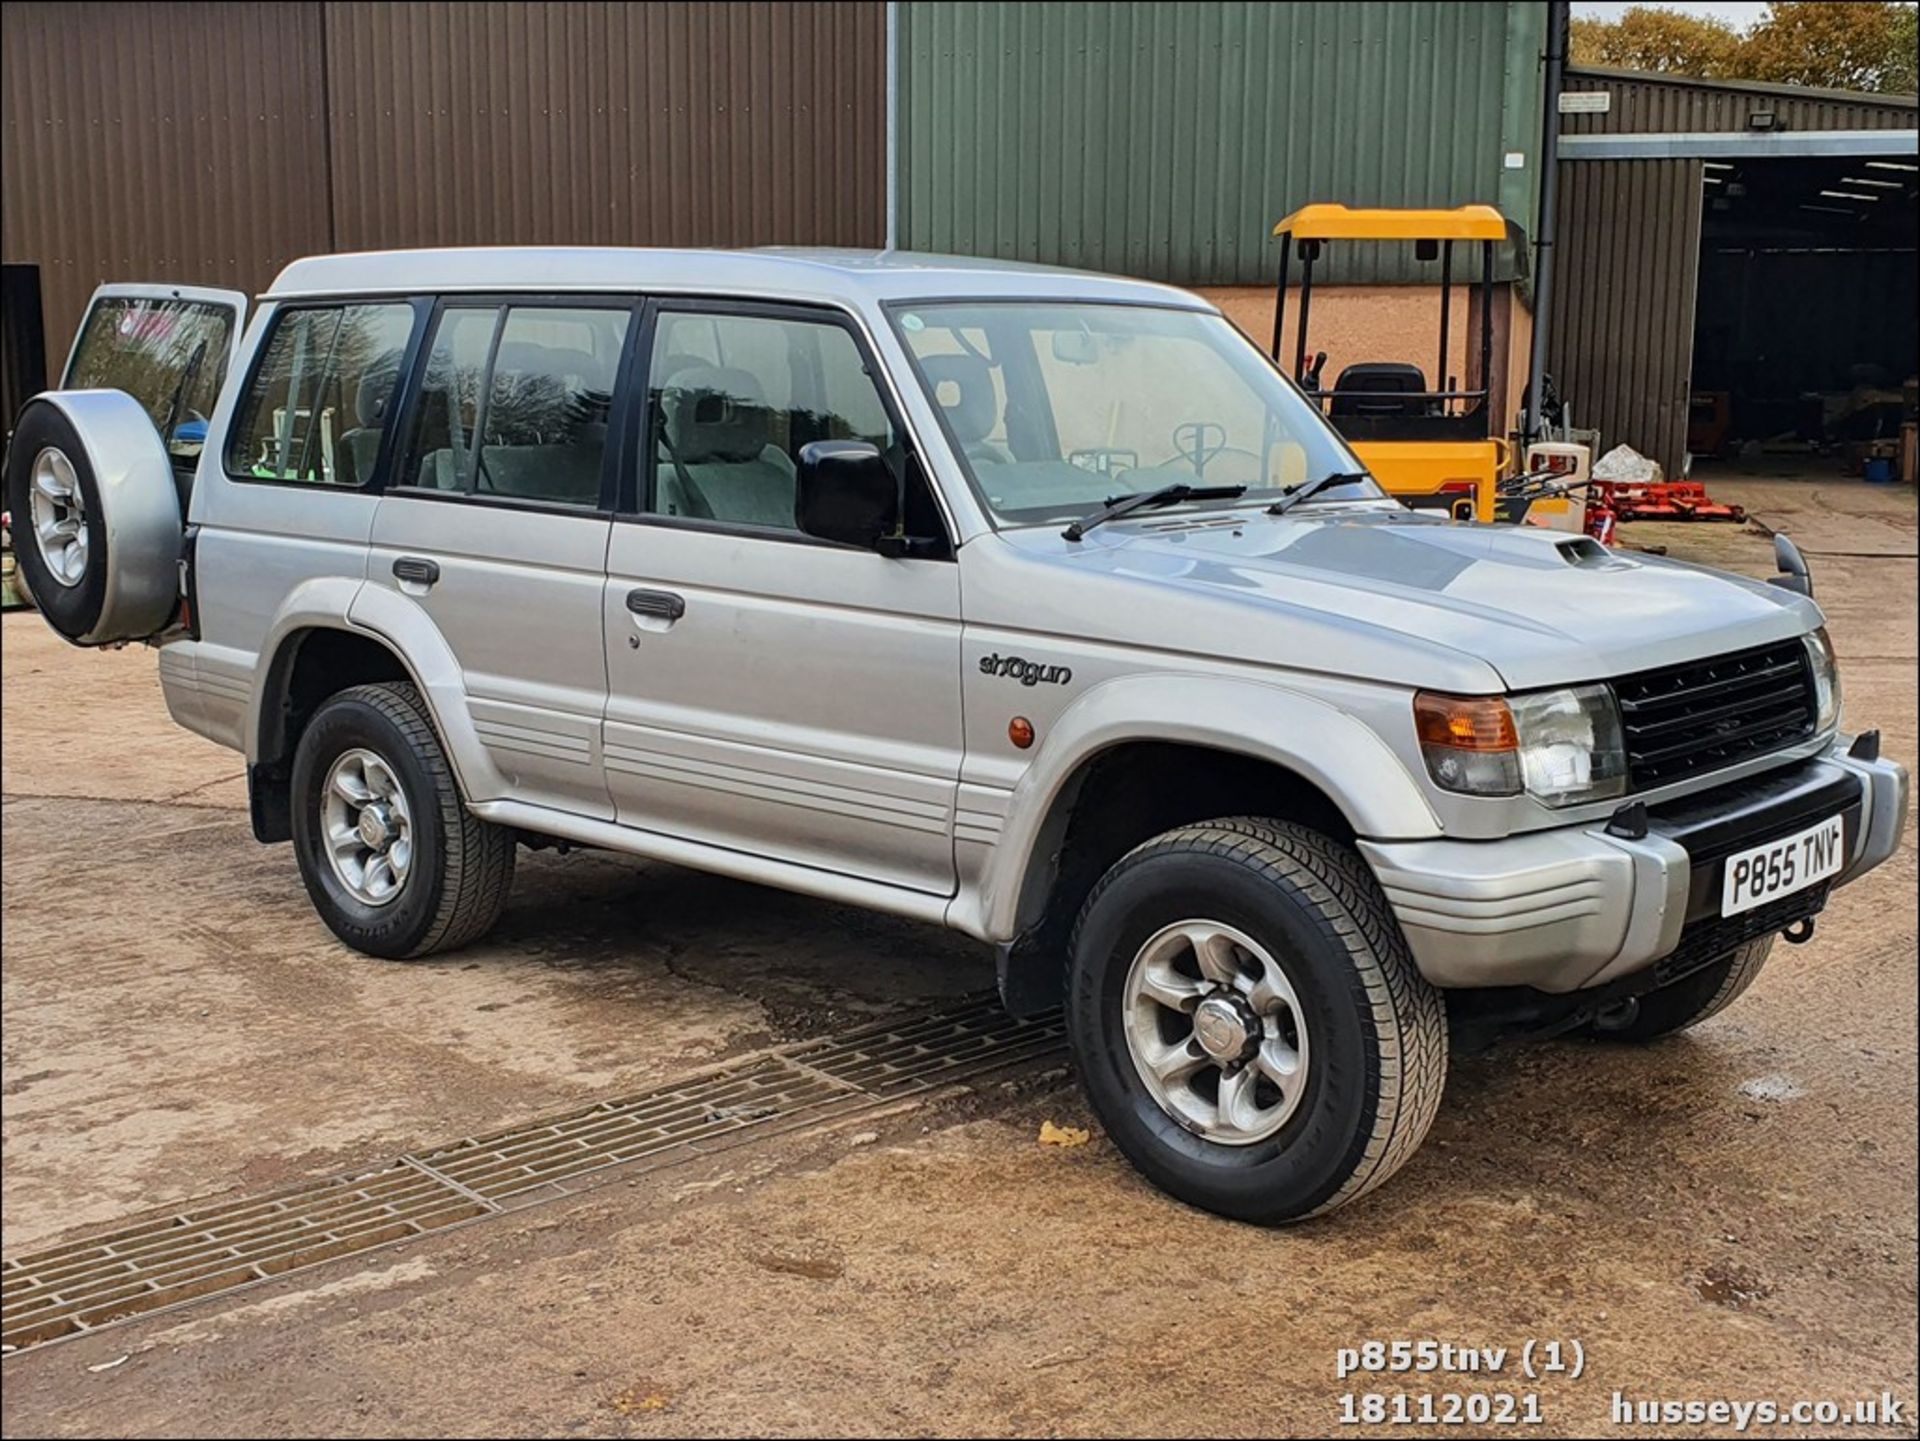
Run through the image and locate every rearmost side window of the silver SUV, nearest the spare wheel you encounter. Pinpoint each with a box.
[227,305,413,485]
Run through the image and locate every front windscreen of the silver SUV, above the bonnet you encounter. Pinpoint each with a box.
[893,301,1382,524]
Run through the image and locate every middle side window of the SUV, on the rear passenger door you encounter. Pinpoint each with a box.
[399,305,630,507]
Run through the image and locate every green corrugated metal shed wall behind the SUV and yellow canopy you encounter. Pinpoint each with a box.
[897,0,1546,286]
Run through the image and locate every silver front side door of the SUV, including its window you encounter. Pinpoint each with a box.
[605,301,962,894]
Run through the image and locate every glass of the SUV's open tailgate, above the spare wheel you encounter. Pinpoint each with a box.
[63,295,234,457]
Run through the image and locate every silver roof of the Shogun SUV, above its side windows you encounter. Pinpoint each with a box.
[267,246,1212,309]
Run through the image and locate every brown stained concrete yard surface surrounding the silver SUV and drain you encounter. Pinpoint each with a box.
[0,478,1920,1435]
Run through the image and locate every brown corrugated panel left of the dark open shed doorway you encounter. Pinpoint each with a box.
[1548,159,1703,476]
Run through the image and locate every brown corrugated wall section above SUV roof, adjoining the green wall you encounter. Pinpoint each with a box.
[326,4,887,249]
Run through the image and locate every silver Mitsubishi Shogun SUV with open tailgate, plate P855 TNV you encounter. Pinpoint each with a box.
[6,249,1908,1222]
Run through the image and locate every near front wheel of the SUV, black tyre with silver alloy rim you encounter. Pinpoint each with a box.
[1068,819,1448,1226]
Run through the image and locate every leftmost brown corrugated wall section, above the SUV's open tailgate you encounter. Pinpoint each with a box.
[0,4,328,402]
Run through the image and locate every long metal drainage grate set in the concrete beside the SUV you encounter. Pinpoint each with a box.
[0,998,1066,1355]
